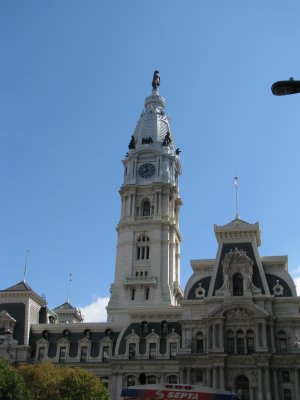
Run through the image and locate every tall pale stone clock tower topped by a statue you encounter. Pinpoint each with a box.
[107,71,182,322]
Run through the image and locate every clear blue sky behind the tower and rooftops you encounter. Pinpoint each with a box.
[0,0,300,319]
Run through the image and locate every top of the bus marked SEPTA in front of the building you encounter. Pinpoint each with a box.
[121,384,239,400]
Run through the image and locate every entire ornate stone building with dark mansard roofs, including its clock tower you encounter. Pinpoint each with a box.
[0,75,300,400]
